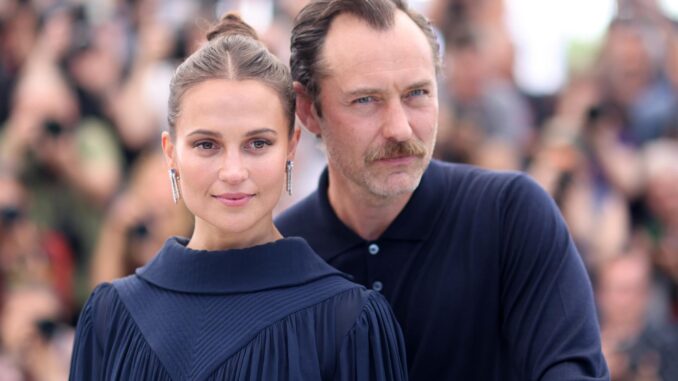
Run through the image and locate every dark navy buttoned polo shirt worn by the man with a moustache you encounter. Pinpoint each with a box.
[276,160,609,381]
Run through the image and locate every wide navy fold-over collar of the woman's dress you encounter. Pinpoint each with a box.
[136,237,345,294]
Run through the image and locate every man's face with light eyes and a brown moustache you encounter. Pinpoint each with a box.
[314,11,438,198]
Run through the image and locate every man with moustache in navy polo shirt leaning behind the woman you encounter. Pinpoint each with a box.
[277,0,609,381]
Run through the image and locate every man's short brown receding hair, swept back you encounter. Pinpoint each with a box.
[290,0,441,115]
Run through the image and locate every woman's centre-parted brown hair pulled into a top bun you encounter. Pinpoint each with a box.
[167,13,295,136]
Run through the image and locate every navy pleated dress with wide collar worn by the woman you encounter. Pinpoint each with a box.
[70,238,407,381]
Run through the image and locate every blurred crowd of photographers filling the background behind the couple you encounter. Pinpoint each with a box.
[0,0,678,381]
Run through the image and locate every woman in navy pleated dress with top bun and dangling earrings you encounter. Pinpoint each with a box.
[71,14,407,380]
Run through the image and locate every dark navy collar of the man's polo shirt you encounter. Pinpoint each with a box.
[309,160,449,259]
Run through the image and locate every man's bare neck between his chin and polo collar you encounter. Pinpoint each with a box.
[327,173,412,241]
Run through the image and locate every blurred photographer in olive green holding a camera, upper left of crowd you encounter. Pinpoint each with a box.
[0,7,122,274]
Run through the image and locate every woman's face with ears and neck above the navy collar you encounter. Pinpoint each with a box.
[162,79,298,249]
